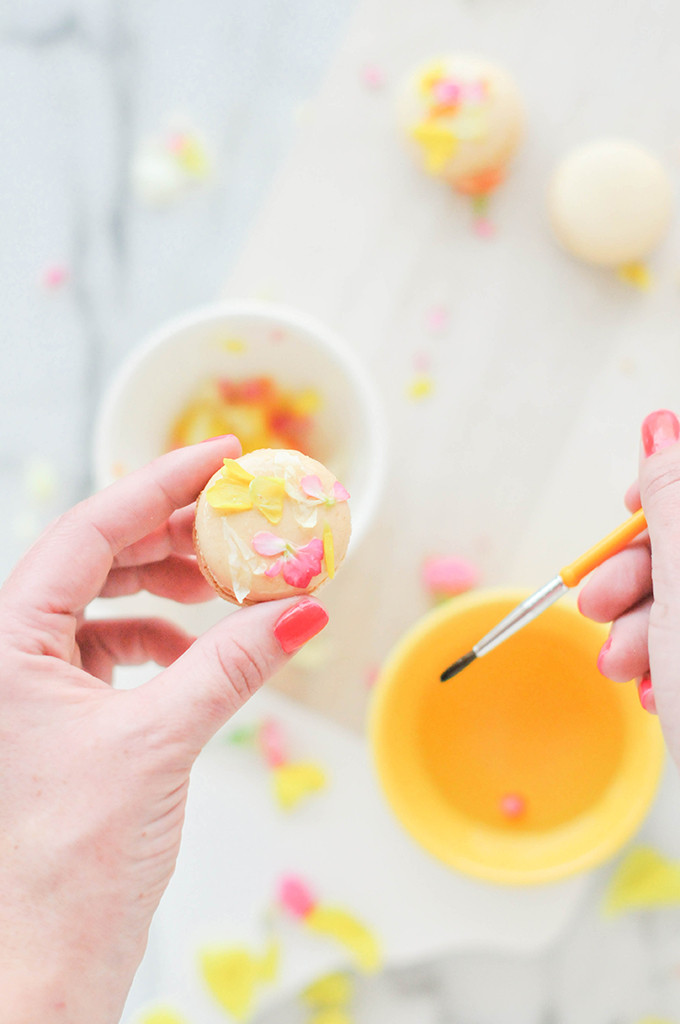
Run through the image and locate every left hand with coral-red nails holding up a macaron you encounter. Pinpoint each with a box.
[0,437,328,1024]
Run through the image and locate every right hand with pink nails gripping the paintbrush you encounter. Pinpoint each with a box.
[579,410,680,765]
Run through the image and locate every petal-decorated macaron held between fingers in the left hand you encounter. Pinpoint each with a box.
[194,449,351,604]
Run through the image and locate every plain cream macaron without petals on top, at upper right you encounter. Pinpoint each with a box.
[548,139,673,268]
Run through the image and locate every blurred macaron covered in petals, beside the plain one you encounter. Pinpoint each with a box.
[400,54,524,196]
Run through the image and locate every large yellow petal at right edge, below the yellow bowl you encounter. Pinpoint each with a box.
[604,847,680,914]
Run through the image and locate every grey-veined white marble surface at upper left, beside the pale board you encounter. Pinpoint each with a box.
[0,0,353,577]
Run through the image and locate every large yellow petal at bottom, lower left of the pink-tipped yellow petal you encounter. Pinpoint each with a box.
[199,943,279,1021]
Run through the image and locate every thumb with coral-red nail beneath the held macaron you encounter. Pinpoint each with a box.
[136,597,328,760]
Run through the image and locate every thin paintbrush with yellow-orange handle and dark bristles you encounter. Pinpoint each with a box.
[440,509,647,683]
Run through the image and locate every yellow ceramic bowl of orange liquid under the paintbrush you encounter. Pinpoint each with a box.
[370,591,664,885]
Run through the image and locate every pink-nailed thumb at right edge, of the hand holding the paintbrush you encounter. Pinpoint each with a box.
[639,410,680,737]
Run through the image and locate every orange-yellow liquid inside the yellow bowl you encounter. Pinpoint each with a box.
[420,622,625,829]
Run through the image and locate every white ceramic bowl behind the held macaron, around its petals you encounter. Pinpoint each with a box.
[94,301,386,549]
